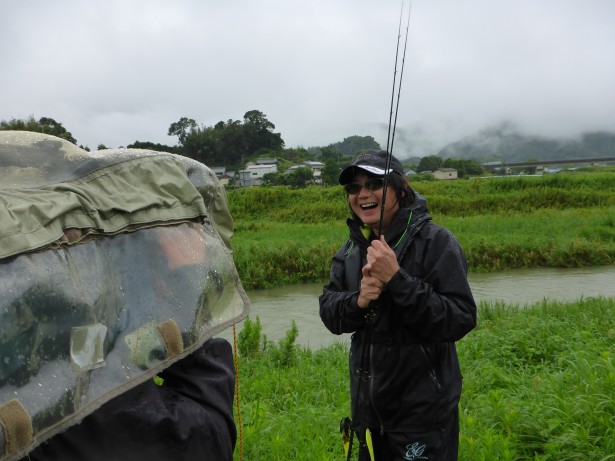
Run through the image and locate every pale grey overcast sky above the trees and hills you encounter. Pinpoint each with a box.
[0,0,615,158]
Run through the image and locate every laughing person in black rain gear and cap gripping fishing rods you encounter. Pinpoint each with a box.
[319,151,476,461]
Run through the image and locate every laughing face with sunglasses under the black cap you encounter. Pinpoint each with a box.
[348,173,399,234]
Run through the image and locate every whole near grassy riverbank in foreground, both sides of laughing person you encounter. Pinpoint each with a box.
[235,298,615,461]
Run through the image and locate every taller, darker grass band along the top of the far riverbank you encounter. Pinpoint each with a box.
[228,173,615,223]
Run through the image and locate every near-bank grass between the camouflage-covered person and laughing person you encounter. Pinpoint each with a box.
[235,336,350,461]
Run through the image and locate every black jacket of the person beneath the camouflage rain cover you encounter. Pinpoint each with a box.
[23,338,236,461]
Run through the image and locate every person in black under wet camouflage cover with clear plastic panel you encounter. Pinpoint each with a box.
[0,131,250,461]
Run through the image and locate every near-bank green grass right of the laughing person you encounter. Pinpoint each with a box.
[459,299,615,460]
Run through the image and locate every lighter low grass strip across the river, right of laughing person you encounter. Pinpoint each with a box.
[446,206,615,272]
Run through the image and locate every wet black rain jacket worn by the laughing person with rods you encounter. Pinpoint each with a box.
[320,194,476,452]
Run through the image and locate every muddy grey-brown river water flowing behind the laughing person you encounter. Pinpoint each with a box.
[221,265,615,349]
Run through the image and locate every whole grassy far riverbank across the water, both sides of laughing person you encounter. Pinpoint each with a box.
[228,172,615,289]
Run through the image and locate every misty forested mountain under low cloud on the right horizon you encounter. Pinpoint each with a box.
[437,126,615,163]
